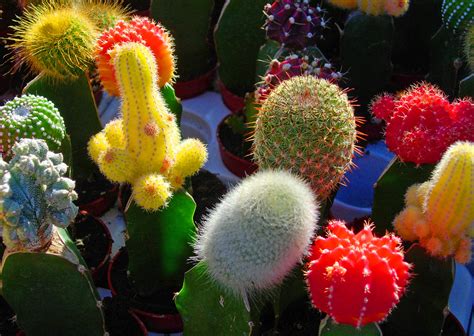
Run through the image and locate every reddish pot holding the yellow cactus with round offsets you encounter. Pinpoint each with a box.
[107,250,183,333]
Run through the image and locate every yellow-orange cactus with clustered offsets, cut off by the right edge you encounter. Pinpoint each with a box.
[394,142,474,263]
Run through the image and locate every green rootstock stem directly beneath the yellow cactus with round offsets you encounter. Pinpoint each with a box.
[125,192,196,296]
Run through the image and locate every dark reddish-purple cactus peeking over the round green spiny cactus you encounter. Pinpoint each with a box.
[255,54,342,103]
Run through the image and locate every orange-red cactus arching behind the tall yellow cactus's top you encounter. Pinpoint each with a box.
[95,16,175,96]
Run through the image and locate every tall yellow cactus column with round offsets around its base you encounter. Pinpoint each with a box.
[89,42,207,211]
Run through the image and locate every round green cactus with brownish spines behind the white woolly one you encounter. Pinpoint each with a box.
[253,76,357,199]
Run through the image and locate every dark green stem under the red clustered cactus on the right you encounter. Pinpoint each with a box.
[372,158,434,236]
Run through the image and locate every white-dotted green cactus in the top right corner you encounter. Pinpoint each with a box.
[441,0,474,31]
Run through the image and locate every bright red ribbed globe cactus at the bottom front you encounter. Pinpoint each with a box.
[306,221,411,327]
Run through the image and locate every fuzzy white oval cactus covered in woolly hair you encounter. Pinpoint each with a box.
[195,170,319,309]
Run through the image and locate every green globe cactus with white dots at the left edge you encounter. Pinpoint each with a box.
[0,94,66,156]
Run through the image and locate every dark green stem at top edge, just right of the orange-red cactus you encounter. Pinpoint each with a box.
[151,0,214,81]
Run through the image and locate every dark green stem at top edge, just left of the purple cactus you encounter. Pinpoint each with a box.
[214,0,268,95]
